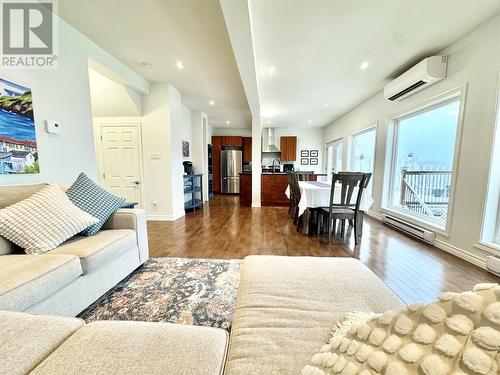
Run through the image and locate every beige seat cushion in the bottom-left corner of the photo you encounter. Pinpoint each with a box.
[0,311,83,375]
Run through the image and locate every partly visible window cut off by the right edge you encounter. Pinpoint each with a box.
[481,75,500,250]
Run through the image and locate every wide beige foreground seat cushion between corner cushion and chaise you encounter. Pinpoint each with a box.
[32,321,228,375]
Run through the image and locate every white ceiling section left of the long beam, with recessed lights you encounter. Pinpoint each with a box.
[59,0,251,128]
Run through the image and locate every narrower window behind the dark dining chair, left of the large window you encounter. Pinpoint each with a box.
[351,127,377,191]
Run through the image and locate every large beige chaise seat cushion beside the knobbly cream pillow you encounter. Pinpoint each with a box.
[226,256,405,375]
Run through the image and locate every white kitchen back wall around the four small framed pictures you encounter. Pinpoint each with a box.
[274,128,324,173]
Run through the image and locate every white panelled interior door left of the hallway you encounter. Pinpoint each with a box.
[101,126,142,207]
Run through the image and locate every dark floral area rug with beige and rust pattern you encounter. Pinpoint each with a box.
[79,258,241,331]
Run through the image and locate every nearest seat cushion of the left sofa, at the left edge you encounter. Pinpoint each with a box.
[0,255,82,311]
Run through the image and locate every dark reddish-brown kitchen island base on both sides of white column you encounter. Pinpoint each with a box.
[240,172,289,207]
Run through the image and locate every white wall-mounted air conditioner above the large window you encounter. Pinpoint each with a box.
[384,56,448,101]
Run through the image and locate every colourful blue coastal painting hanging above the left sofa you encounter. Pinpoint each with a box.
[0,77,40,175]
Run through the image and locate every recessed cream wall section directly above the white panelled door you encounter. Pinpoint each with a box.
[89,68,142,117]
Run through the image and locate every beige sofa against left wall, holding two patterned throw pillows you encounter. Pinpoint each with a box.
[0,184,149,316]
